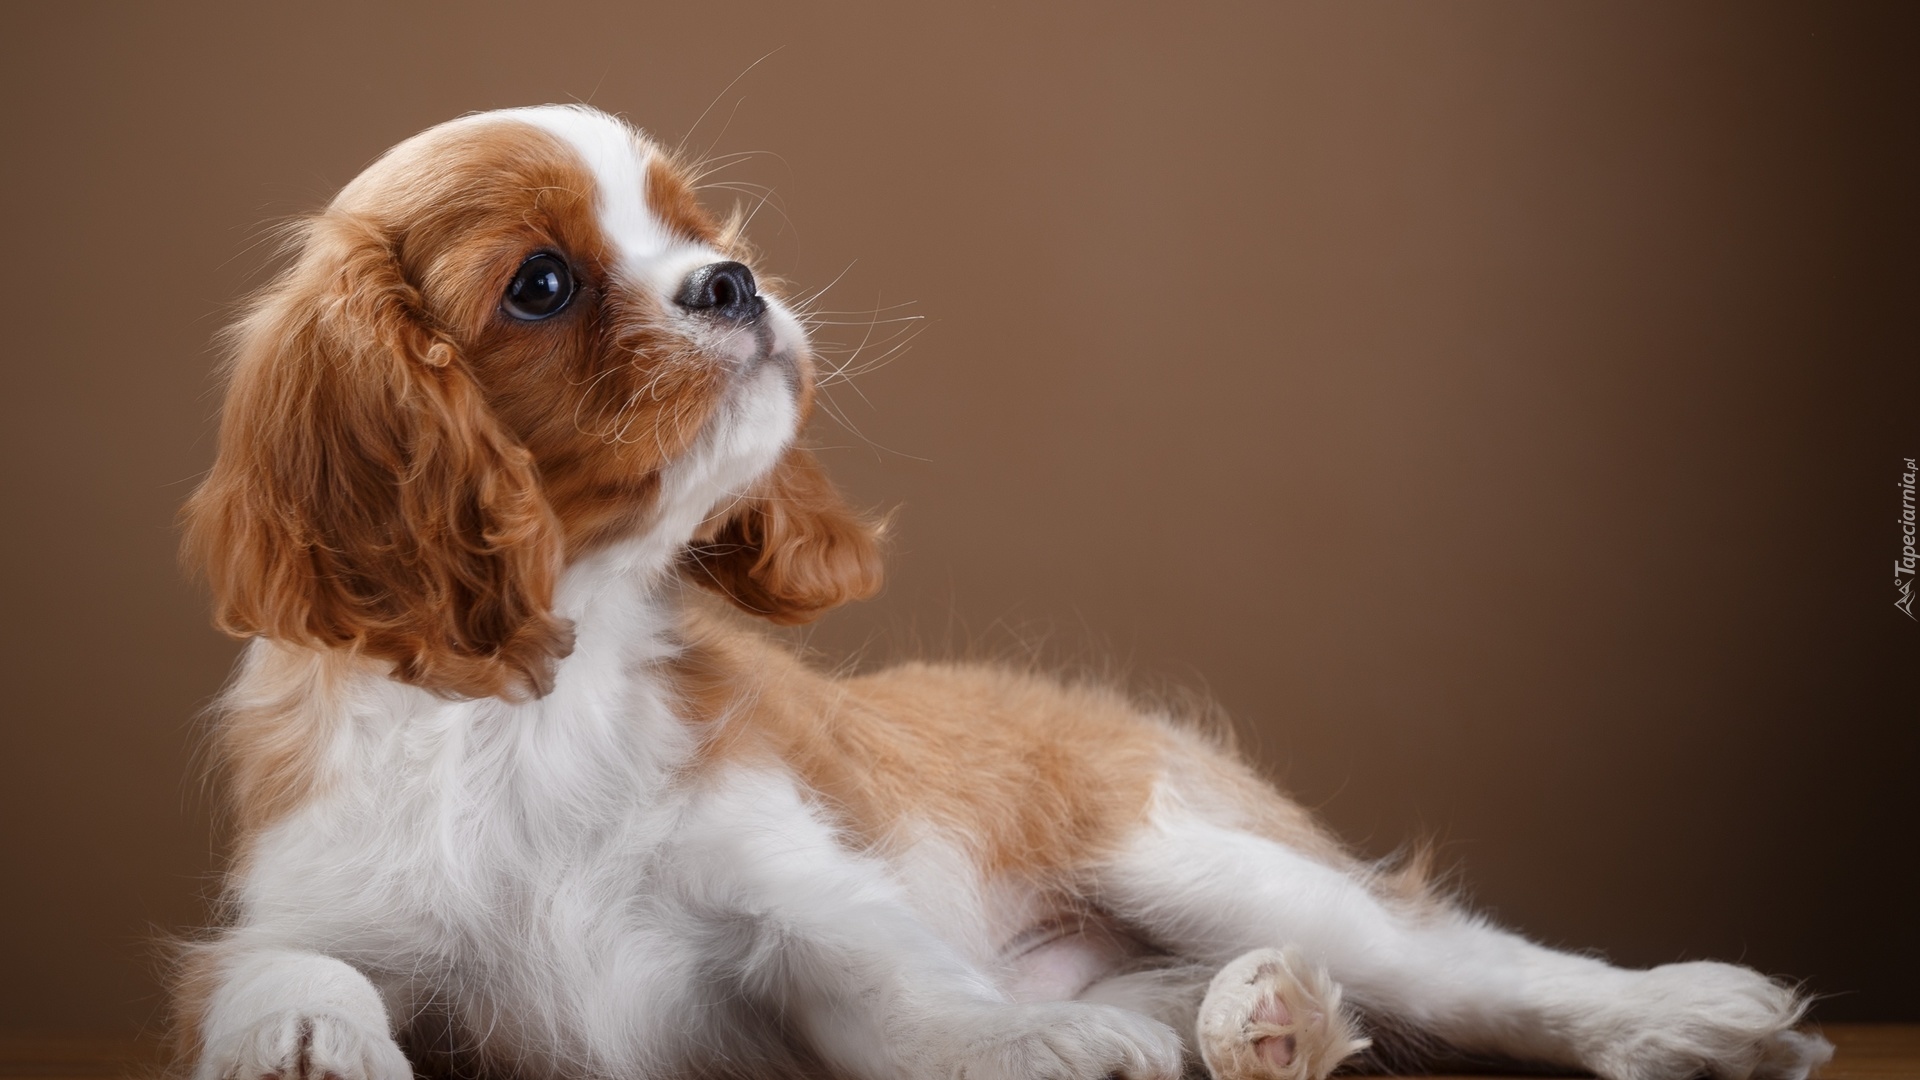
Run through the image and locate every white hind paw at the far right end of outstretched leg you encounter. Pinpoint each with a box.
[1584,963,1834,1080]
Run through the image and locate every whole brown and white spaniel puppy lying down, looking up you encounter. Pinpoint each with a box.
[179,108,1830,1080]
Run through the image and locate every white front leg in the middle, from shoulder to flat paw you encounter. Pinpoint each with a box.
[674,771,1181,1080]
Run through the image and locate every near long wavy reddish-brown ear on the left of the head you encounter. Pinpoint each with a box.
[184,211,572,698]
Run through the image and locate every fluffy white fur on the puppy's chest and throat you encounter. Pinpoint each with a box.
[222,552,733,1045]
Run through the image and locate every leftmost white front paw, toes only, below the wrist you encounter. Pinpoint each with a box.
[194,1013,413,1080]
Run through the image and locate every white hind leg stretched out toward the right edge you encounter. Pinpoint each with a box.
[1098,809,1832,1080]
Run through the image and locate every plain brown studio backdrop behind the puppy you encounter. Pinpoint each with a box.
[0,0,1920,1032]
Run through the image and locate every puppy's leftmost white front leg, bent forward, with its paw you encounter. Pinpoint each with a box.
[194,949,413,1080]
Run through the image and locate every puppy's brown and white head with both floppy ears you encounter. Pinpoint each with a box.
[186,108,879,698]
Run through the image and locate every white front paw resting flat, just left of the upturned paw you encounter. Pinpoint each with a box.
[943,1001,1181,1080]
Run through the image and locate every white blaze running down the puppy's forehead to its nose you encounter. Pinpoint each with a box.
[488,106,714,296]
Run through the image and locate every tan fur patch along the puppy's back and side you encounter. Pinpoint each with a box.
[672,599,1173,880]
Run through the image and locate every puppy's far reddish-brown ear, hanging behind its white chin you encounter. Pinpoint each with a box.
[682,448,883,625]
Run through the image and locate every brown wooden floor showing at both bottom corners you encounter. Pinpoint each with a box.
[0,1024,1920,1080]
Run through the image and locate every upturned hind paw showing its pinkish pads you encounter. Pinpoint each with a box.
[1194,949,1369,1080]
